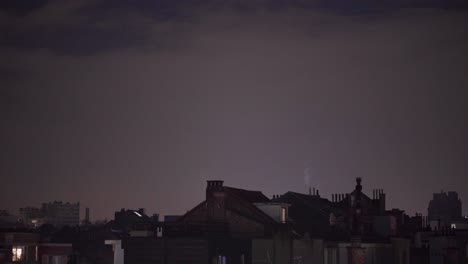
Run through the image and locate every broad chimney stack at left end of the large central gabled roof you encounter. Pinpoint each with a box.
[206,180,226,222]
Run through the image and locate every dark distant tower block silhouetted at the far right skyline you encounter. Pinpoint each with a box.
[428,191,462,229]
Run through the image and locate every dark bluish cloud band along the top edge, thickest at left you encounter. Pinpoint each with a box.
[0,0,466,55]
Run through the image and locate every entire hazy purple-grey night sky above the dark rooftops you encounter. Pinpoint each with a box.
[0,0,468,220]
